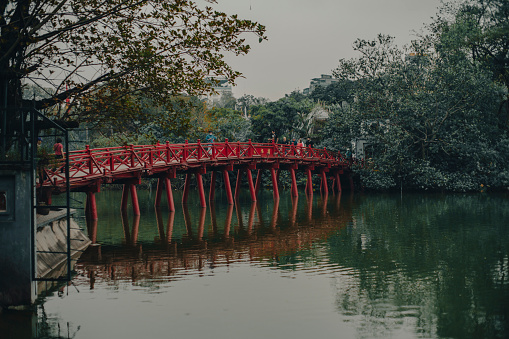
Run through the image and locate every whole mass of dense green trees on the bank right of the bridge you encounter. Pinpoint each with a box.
[322,0,509,191]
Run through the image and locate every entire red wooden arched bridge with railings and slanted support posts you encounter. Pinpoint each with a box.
[37,139,352,219]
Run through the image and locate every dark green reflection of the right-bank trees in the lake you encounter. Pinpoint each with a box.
[322,195,509,338]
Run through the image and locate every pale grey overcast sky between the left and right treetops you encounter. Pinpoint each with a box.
[206,0,441,100]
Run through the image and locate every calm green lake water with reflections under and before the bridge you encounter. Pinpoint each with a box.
[0,191,509,339]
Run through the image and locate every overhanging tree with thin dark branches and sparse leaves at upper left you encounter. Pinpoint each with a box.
[0,0,266,132]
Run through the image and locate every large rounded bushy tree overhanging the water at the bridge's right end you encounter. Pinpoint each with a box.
[325,35,508,191]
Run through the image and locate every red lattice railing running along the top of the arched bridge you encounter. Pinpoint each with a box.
[39,139,348,186]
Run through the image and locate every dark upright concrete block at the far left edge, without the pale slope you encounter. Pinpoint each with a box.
[0,169,37,308]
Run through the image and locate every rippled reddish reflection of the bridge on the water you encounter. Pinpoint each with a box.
[76,194,351,288]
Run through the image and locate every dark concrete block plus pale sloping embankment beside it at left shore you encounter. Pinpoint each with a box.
[0,169,90,310]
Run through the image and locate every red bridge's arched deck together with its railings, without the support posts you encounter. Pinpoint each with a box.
[37,140,350,192]
